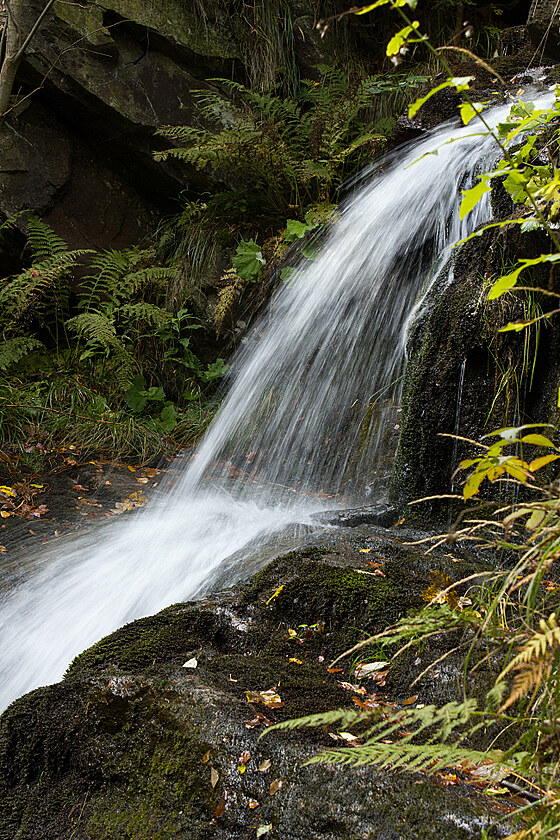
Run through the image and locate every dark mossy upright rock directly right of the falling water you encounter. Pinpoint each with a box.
[393,201,560,513]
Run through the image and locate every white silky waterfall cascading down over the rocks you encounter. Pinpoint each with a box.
[0,100,528,708]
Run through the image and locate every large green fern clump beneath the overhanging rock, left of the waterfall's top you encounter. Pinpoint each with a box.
[155,68,394,212]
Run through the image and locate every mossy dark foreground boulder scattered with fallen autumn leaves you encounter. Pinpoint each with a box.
[0,529,507,840]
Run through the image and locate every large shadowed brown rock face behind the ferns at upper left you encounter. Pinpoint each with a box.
[0,0,350,260]
